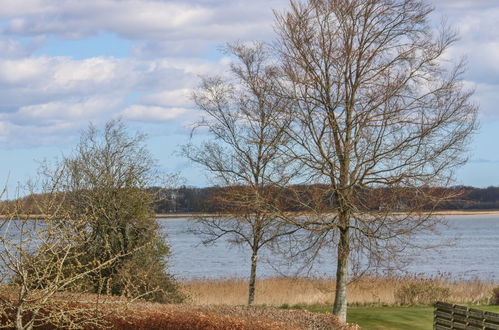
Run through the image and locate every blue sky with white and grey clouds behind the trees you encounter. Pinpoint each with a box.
[0,0,499,187]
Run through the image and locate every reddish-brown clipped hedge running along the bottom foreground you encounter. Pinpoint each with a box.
[0,287,358,330]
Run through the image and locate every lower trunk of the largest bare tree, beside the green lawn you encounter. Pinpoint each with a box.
[333,227,350,322]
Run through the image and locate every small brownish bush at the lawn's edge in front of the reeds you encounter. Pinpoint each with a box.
[395,280,450,305]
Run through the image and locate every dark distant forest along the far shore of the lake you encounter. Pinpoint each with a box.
[0,185,499,214]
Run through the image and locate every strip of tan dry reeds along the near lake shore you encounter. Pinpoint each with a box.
[183,277,497,306]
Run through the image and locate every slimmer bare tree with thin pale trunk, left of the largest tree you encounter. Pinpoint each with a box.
[184,43,296,305]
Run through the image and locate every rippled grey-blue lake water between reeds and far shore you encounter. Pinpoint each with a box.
[159,215,499,282]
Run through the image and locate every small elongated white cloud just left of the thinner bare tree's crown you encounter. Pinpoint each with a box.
[121,105,188,123]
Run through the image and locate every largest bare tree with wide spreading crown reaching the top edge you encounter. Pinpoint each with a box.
[276,0,477,320]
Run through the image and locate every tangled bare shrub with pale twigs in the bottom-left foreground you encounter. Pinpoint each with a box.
[0,181,125,330]
